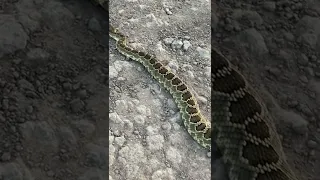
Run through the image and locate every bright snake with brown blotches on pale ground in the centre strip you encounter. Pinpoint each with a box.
[109,26,211,150]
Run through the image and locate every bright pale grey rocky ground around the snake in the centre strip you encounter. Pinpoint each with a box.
[109,0,211,180]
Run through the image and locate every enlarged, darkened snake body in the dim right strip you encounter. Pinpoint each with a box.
[211,49,297,180]
